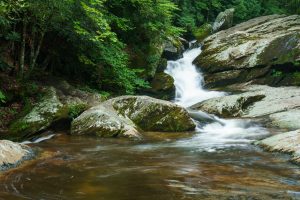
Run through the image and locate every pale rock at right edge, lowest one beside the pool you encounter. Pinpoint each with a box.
[256,130,300,164]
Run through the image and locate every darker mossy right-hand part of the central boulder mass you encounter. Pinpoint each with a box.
[106,96,195,132]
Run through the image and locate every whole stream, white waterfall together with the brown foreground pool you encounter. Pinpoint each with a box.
[0,48,300,200]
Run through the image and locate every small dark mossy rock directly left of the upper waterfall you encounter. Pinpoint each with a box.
[150,72,175,100]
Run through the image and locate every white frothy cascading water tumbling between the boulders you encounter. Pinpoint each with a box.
[165,47,268,151]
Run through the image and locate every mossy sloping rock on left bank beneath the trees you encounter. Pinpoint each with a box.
[8,80,101,141]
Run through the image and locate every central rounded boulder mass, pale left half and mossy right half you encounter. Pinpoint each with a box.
[71,96,195,138]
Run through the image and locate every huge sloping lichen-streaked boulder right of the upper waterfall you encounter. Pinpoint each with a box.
[194,15,300,87]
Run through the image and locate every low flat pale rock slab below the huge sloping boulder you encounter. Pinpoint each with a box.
[193,85,300,130]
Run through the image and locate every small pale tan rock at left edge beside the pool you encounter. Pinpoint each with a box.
[0,140,34,171]
